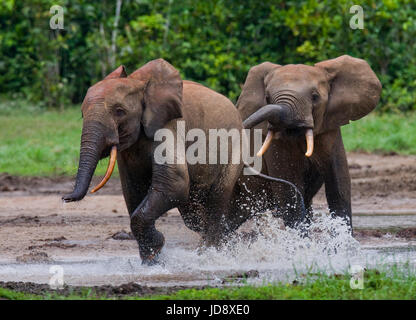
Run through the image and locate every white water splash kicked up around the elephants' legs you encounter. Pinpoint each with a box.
[161,213,360,281]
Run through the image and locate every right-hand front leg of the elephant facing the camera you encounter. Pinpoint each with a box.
[325,130,352,232]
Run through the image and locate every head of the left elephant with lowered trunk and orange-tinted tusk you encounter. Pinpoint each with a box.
[63,59,182,202]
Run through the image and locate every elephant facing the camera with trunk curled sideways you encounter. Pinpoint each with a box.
[237,55,381,232]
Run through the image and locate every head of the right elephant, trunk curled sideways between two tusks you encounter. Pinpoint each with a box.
[237,55,381,157]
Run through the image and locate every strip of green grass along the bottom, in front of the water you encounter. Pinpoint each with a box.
[0,270,416,300]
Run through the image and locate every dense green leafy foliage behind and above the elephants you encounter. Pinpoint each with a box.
[0,0,416,111]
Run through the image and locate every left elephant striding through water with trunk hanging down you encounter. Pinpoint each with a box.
[63,59,296,264]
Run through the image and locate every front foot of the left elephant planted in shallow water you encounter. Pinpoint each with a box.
[138,229,165,266]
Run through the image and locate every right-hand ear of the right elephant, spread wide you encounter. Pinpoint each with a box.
[315,55,381,130]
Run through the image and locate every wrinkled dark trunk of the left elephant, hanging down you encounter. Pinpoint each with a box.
[62,121,116,202]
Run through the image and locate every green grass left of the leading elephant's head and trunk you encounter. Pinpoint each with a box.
[0,102,110,176]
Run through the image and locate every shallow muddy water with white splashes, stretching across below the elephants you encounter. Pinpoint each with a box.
[0,214,416,286]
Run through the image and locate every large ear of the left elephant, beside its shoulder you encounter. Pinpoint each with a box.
[129,59,183,139]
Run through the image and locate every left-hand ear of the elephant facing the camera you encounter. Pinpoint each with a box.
[237,62,280,121]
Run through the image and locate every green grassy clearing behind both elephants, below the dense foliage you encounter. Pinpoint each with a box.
[0,101,416,176]
